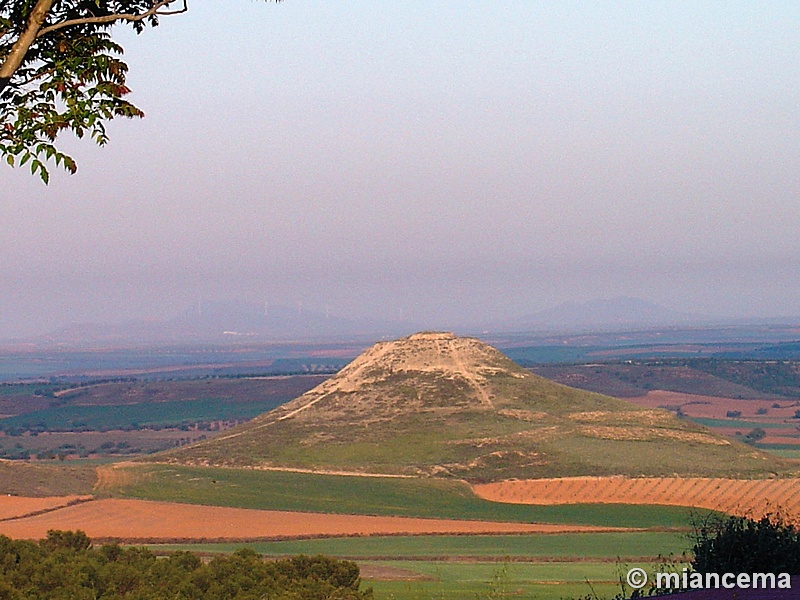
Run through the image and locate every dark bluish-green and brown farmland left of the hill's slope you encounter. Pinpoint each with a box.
[0,375,326,459]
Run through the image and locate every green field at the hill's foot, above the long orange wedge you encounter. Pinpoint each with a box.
[109,464,708,528]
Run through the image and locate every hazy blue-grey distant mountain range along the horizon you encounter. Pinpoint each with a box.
[21,297,800,346]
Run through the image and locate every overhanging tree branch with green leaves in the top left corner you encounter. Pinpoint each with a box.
[0,0,280,183]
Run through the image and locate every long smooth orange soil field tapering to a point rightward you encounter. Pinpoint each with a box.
[0,498,619,542]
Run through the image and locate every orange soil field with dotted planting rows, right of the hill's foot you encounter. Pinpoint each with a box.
[473,477,800,517]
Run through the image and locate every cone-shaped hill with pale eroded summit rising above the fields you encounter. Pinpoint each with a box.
[154,332,784,481]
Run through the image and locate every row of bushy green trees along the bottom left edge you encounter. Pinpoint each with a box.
[0,531,373,600]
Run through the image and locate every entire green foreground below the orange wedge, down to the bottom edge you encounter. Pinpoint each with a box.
[151,531,690,600]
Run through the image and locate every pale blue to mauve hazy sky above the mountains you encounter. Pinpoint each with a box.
[0,0,800,338]
